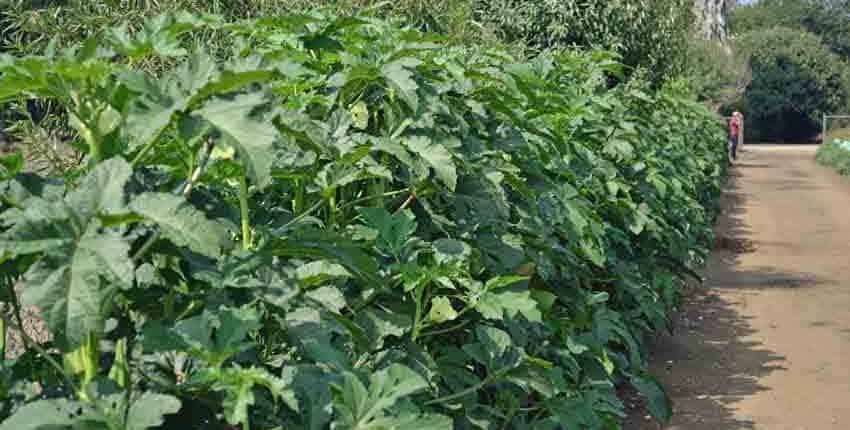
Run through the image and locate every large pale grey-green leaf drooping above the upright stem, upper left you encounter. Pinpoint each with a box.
[195,93,278,188]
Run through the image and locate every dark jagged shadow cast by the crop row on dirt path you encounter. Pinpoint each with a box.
[624,163,827,430]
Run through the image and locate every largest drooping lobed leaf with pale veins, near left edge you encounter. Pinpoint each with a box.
[23,223,134,349]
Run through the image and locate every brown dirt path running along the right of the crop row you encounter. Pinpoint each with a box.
[625,145,850,430]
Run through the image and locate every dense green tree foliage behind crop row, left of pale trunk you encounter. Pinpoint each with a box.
[475,0,694,83]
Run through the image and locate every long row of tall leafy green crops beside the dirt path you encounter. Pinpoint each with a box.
[0,13,726,430]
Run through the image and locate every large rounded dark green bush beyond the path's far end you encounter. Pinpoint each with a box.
[740,28,850,140]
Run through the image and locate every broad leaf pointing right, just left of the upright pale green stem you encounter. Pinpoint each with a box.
[130,193,228,258]
